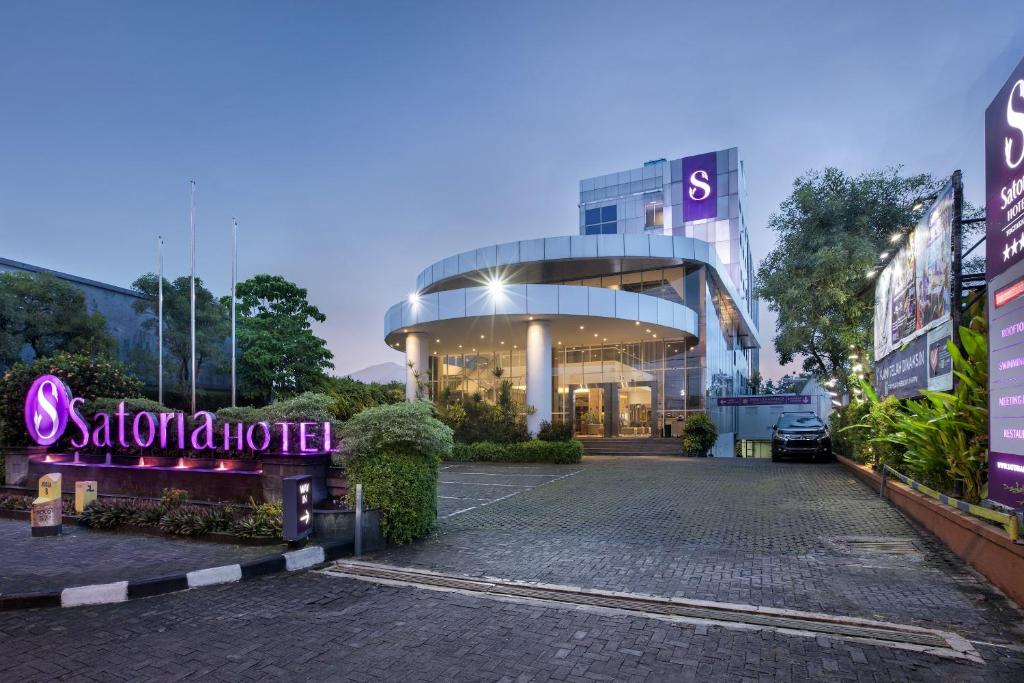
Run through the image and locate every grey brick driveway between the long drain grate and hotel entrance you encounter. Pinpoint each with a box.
[372,458,1024,647]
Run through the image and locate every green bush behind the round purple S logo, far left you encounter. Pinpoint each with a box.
[0,352,142,447]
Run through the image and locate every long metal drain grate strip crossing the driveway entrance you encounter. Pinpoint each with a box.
[323,560,981,663]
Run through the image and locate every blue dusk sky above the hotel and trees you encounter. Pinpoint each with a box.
[0,0,1024,378]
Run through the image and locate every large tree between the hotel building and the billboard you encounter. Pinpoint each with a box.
[757,168,945,388]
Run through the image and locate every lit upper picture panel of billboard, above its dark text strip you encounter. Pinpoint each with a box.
[874,182,953,361]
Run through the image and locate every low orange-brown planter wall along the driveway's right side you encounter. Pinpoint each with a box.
[836,456,1024,605]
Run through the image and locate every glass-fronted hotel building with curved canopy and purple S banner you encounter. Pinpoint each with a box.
[385,147,760,443]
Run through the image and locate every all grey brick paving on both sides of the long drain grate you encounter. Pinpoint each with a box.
[0,459,1024,683]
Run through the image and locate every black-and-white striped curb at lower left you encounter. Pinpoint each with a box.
[0,541,353,611]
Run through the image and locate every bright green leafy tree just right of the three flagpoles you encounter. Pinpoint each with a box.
[221,274,334,400]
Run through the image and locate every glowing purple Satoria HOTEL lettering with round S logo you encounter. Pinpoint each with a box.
[25,375,332,455]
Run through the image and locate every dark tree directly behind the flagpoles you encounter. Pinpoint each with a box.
[132,272,230,392]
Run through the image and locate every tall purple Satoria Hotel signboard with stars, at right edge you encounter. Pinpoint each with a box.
[985,59,1024,508]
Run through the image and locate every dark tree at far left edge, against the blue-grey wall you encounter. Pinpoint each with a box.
[0,272,117,368]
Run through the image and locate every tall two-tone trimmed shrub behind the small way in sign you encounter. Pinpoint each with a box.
[342,401,452,543]
